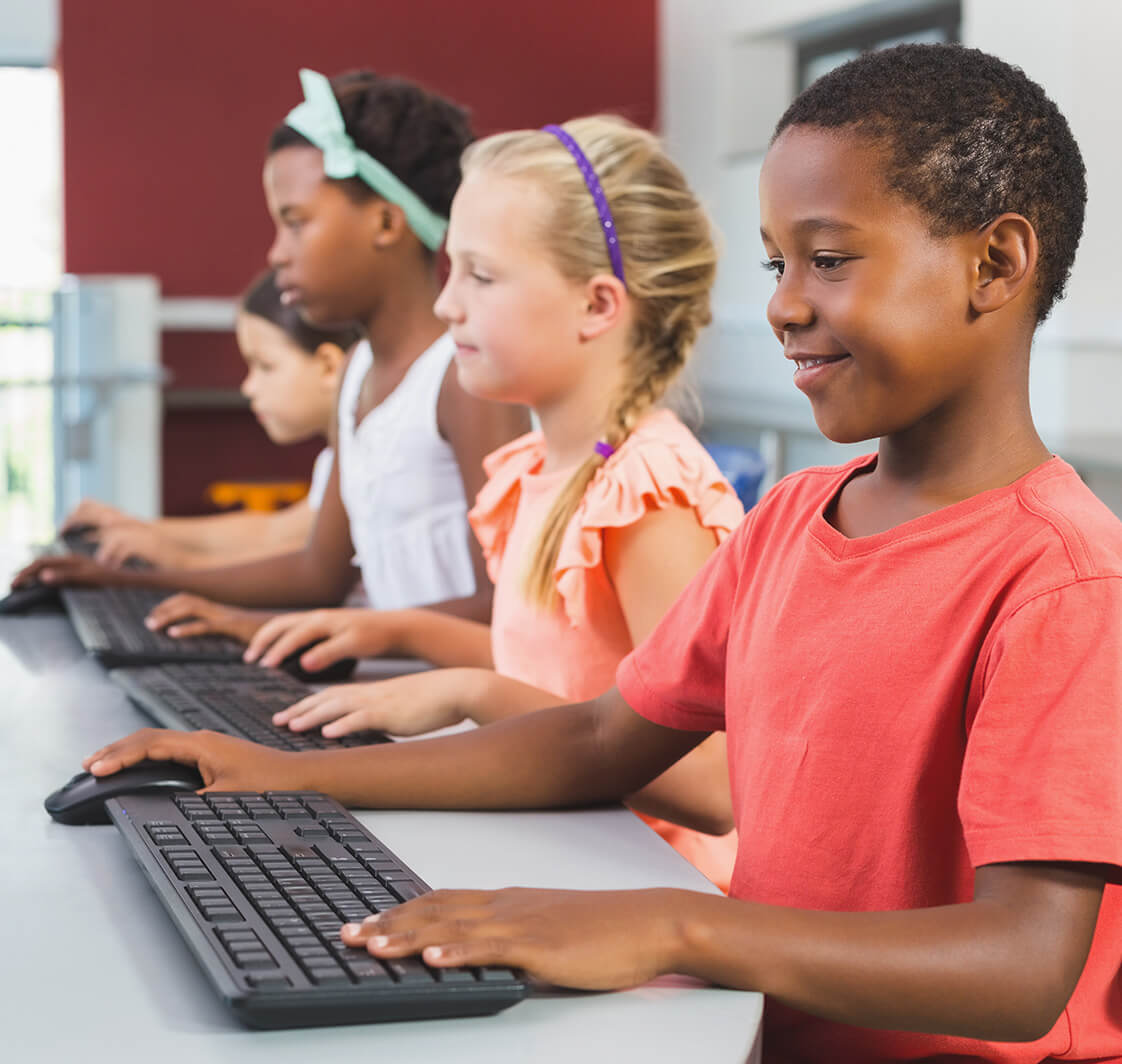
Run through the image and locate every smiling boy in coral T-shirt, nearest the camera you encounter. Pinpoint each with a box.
[83,45,1122,1064]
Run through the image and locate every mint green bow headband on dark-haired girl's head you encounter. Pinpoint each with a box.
[284,70,448,251]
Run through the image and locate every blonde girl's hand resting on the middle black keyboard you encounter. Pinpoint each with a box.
[273,669,482,739]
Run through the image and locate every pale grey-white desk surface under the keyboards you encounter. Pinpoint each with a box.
[0,614,762,1064]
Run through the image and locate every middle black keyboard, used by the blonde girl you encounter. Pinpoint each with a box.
[109,662,389,750]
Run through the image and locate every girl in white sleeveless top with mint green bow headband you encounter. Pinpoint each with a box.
[17,71,528,639]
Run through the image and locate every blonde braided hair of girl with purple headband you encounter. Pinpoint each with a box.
[462,116,717,607]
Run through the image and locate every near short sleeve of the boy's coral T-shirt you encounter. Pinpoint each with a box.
[958,576,1122,882]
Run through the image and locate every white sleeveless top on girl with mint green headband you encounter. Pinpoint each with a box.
[337,333,476,609]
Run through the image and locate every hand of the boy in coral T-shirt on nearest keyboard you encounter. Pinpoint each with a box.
[341,888,682,990]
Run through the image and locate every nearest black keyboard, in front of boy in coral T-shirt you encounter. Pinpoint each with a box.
[105,791,527,1027]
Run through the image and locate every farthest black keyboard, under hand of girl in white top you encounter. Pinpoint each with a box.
[61,587,246,668]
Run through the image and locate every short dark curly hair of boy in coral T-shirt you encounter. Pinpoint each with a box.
[772,44,1087,323]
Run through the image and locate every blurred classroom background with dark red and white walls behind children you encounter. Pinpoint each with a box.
[0,0,1122,562]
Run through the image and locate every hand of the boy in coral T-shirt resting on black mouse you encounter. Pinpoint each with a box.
[82,727,306,791]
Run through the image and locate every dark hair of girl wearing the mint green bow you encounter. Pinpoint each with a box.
[267,71,475,226]
